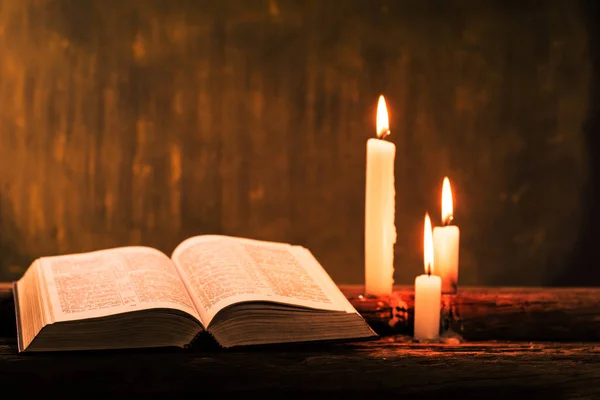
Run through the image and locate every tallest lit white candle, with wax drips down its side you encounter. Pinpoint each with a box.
[364,96,396,296]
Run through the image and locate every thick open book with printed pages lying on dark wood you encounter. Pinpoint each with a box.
[13,235,377,352]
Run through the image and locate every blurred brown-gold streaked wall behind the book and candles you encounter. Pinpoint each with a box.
[0,0,600,285]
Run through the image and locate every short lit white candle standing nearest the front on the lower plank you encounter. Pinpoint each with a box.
[414,214,442,340]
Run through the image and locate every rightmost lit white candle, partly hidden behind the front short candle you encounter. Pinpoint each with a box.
[433,177,460,294]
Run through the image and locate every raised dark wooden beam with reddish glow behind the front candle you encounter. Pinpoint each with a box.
[341,285,600,342]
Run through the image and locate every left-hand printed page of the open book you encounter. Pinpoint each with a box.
[40,246,200,321]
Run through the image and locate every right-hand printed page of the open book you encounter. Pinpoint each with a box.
[171,235,352,326]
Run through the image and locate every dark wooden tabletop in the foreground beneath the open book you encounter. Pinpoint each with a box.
[0,284,600,399]
